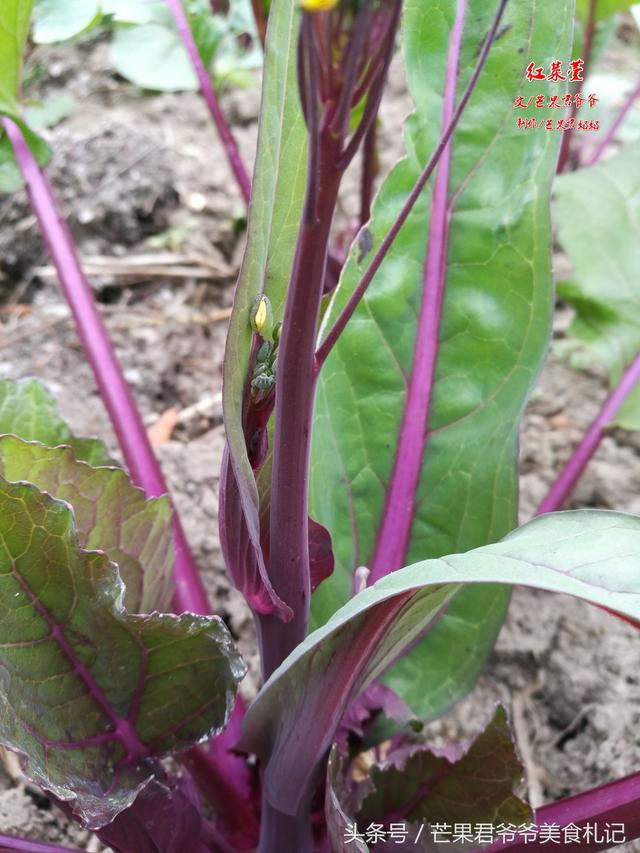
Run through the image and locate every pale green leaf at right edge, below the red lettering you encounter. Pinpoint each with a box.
[554,143,640,429]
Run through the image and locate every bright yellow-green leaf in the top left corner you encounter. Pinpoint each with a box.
[0,0,33,118]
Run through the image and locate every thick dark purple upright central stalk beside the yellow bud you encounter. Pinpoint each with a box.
[258,146,341,679]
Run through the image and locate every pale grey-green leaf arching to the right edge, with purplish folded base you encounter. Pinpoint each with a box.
[242,510,640,814]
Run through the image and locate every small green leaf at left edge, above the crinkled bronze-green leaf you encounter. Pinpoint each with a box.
[0,379,116,466]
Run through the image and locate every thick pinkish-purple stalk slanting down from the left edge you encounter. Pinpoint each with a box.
[2,118,211,614]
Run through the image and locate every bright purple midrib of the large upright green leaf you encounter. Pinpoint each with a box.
[369,0,468,583]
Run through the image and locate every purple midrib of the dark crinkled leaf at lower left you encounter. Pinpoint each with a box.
[12,569,150,763]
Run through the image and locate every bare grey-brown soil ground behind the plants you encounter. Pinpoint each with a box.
[0,26,640,853]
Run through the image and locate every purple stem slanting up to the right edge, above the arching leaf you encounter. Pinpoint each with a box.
[535,353,640,515]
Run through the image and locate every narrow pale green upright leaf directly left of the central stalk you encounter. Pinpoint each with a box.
[223,0,307,524]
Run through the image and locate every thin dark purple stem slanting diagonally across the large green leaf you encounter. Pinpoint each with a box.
[316,0,509,371]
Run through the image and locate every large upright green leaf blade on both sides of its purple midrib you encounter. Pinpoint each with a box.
[311,0,573,718]
